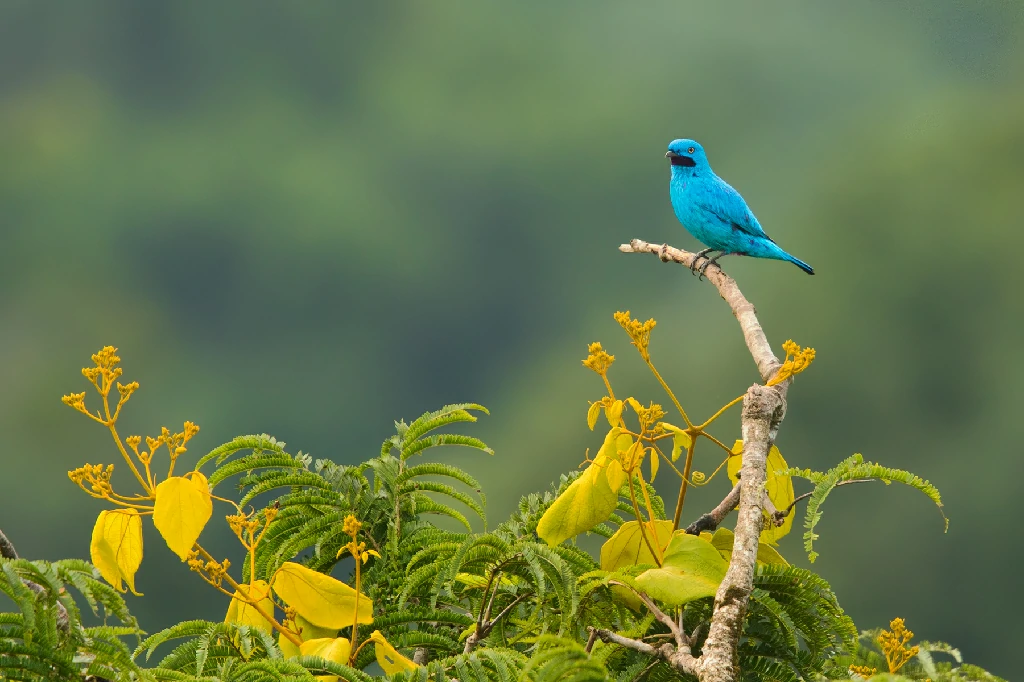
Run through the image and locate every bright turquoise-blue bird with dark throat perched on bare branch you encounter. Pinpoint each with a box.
[665,139,814,274]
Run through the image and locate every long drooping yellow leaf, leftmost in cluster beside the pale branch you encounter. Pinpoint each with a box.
[537,427,633,546]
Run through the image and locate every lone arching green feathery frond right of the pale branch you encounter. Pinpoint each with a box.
[785,455,949,563]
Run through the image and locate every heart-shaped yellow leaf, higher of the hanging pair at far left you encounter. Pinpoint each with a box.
[153,471,213,561]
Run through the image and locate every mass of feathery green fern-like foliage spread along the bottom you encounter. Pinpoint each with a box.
[0,404,998,682]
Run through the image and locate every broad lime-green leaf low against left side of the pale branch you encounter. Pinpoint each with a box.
[637,530,729,606]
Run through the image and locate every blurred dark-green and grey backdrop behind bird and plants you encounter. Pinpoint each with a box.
[0,0,1024,675]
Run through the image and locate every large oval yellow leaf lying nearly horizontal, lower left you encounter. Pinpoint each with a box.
[270,561,374,629]
